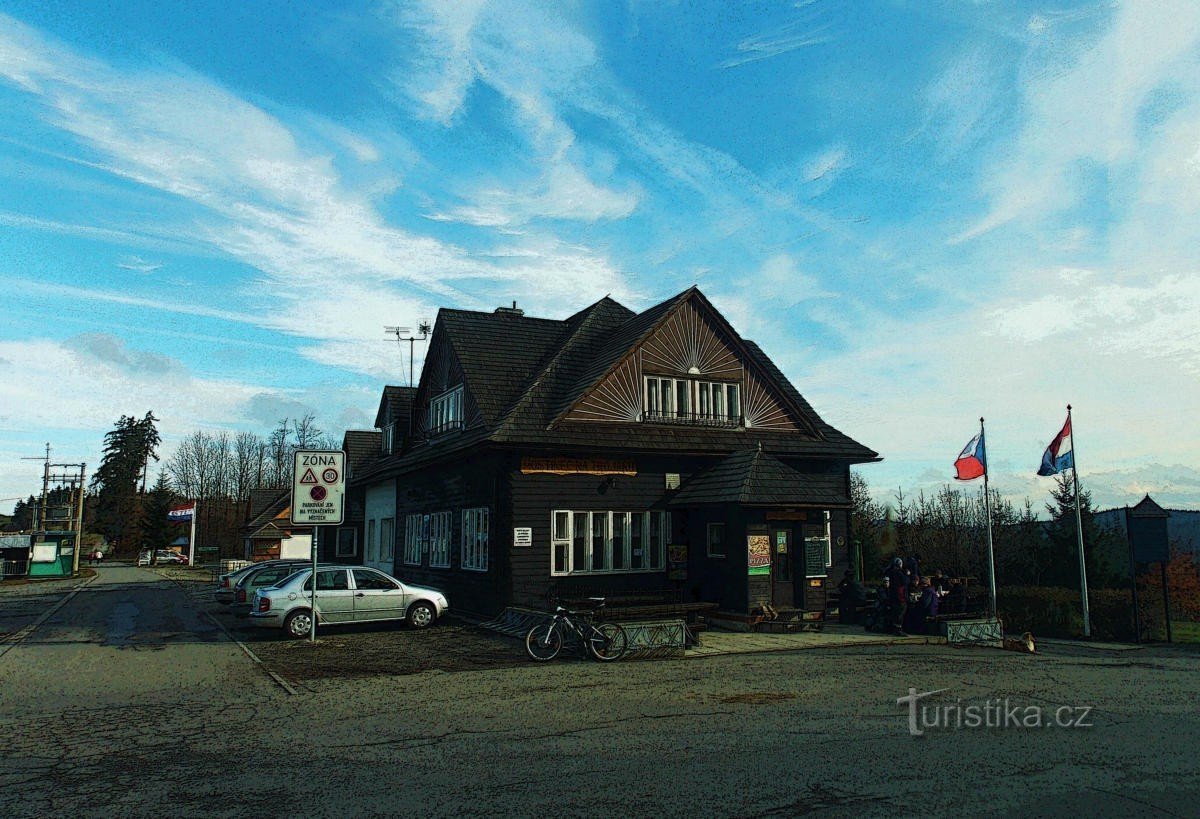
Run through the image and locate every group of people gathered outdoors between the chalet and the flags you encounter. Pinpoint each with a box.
[839,552,965,636]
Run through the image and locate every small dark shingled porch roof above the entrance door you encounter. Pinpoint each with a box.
[671,449,850,508]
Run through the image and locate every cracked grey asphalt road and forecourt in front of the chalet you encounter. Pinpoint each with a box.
[0,567,1200,817]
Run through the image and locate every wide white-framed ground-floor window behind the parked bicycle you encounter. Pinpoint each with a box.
[551,510,671,574]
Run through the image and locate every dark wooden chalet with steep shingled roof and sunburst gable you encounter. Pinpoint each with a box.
[350,287,878,615]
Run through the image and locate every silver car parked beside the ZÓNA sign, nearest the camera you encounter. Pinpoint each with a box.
[250,566,450,638]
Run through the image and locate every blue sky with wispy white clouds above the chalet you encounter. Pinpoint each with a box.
[0,0,1200,509]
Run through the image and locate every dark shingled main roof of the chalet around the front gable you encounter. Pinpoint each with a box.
[355,287,878,483]
